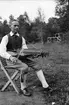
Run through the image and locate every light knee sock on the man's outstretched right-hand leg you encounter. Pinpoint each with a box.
[36,70,49,88]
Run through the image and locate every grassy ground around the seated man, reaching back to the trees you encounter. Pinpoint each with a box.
[0,43,69,105]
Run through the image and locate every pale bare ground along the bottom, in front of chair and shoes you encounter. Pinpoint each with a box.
[0,88,49,105]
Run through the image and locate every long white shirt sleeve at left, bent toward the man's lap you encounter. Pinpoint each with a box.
[0,35,11,59]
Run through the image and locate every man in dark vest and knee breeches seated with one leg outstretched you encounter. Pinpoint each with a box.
[0,20,49,96]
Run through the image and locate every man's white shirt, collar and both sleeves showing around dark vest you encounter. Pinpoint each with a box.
[0,32,28,59]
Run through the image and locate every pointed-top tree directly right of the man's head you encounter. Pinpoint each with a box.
[17,12,31,40]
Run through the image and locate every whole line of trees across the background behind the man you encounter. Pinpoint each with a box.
[0,0,69,43]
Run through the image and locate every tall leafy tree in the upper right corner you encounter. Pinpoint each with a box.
[56,0,69,32]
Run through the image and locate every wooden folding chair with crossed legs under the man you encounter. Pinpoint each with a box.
[0,57,19,94]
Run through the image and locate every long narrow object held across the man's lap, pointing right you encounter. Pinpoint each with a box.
[8,49,49,58]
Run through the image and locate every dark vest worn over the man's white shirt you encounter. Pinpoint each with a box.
[6,34,22,51]
